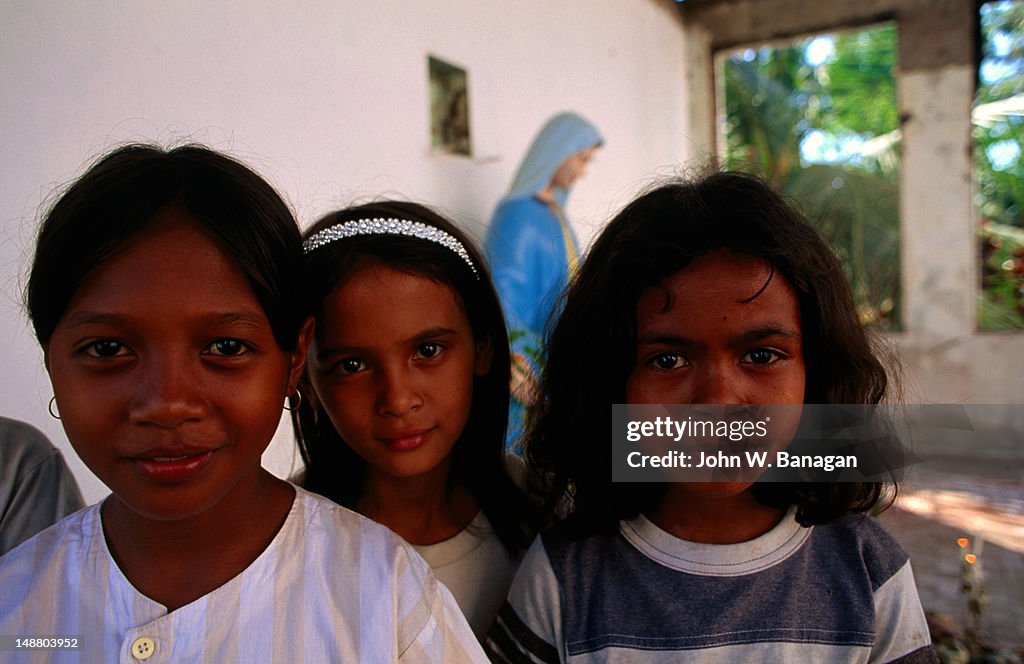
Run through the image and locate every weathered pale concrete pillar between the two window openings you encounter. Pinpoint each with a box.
[897,0,977,342]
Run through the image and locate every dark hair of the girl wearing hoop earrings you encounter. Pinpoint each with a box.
[26,144,308,350]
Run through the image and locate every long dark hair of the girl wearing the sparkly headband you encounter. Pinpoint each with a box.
[292,201,537,552]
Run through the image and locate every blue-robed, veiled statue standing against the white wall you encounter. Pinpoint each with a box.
[484,113,603,449]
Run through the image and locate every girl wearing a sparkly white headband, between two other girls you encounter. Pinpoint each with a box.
[293,202,535,635]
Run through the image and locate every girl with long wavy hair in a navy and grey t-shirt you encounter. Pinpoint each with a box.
[486,172,936,664]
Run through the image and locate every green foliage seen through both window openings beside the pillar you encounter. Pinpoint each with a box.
[721,7,1024,330]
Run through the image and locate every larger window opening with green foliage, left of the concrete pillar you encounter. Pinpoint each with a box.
[716,25,900,329]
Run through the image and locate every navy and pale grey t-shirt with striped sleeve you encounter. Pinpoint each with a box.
[487,511,937,663]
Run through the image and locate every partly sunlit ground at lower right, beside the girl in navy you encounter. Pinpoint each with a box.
[880,454,1024,651]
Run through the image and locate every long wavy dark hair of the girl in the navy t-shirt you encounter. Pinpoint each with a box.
[525,172,888,536]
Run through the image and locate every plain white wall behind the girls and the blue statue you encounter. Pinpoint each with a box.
[0,0,694,500]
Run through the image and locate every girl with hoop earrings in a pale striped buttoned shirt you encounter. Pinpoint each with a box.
[0,146,485,663]
